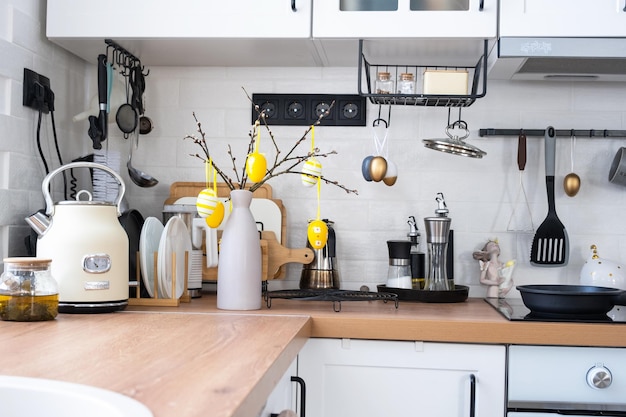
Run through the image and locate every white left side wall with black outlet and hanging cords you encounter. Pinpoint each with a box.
[0,0,89,260]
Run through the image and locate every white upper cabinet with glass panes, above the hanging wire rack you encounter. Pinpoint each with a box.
[313,0,498,39]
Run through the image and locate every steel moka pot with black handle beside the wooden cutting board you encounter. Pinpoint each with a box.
[300,219,340,290]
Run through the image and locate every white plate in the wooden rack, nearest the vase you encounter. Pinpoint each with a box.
[158,217,192,299]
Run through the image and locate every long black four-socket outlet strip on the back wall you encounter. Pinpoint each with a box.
[252,94,367,126]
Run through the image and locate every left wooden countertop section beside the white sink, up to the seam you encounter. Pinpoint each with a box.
[0,313,310,417]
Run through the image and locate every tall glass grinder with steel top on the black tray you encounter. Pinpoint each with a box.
[424,193,453,291]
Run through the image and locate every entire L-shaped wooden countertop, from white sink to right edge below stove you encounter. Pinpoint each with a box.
[0,294,626,417]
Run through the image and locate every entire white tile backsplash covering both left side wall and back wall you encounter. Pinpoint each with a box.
[0,0,626,297]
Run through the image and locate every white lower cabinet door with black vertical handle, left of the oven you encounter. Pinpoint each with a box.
[298,339,505,417]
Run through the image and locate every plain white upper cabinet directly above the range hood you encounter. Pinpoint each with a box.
[500,0,626,37]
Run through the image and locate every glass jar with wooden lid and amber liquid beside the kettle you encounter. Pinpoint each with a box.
[0,257,59,321]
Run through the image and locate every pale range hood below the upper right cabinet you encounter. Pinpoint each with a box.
[489,37,626,82]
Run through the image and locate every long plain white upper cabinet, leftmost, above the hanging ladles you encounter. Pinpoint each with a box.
[46,0,311,39]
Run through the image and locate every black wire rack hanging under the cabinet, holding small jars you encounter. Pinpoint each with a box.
[358,39,489,107]
